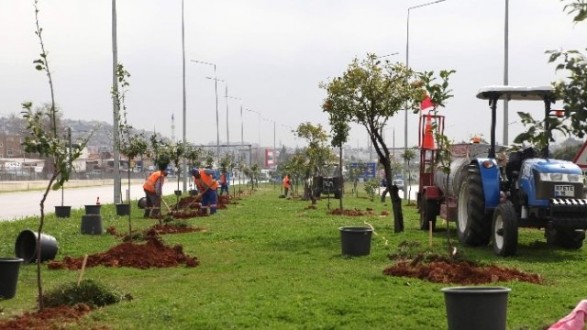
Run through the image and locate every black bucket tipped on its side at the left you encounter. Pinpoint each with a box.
[14,229,59,264]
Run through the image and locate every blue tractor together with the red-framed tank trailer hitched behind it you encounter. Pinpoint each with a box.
[418,86,587,256]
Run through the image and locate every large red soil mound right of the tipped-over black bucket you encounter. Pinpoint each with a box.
[47,229,200,270]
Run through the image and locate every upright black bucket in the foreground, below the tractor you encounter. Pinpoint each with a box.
[441,286,511,330]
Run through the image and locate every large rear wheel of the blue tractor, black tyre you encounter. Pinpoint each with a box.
[457,164,491,246]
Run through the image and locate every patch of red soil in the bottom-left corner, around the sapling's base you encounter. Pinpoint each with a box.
[0,304,91,330]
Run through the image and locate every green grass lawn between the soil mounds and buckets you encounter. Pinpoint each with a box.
[0,185,587,329]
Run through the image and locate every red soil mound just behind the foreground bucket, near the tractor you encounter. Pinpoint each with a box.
[383,256,542,285]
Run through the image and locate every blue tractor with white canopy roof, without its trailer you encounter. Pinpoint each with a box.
[456,86,587,256]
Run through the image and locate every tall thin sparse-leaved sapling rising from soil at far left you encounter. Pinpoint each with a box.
[22,1,89,311]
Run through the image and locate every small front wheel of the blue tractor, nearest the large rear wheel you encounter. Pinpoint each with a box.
[491,201,518,257]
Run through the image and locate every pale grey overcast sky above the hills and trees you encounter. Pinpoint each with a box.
[0,0,587,152]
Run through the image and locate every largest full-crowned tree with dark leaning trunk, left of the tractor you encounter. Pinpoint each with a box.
[320,54,452,232]
